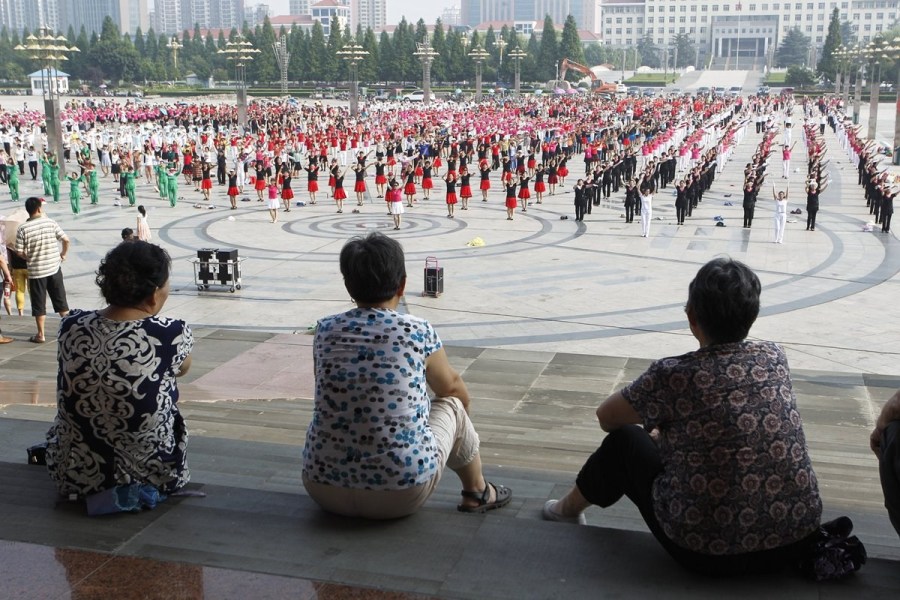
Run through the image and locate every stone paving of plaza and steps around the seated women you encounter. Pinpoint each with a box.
[0,92,900,598]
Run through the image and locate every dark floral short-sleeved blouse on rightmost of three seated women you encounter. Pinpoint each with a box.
[622,341,822,555]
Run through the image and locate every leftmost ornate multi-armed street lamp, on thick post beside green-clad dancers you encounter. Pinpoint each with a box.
[14,27,80,178]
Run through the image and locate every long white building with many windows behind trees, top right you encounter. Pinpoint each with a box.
[599,0,900,68]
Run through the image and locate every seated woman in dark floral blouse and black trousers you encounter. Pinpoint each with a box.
[544,258,822,575]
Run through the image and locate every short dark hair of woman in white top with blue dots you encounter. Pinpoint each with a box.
[340,232,406,304]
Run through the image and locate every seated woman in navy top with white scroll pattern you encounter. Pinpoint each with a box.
[46,240,193,504]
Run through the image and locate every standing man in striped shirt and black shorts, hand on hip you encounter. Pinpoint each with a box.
[16,196,69,344]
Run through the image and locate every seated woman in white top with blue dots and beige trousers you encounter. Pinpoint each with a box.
[303,233,512,519]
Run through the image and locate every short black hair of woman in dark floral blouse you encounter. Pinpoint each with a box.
[687,257,762,344]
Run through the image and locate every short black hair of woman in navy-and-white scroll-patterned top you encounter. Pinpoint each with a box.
[95,240,172,307]
